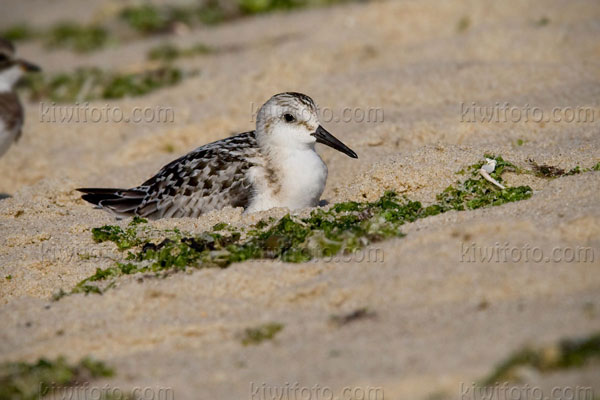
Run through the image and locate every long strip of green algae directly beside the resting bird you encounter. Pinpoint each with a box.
[55,155,532,299]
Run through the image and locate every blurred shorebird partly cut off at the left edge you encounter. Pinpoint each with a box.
[0,38,39,157]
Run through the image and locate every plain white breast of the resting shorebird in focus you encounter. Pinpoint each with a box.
[246,148,327,212]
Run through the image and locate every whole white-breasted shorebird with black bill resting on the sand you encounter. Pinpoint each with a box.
[77,92,358,219]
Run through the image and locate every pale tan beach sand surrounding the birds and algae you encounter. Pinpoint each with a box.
[0,0,600,399]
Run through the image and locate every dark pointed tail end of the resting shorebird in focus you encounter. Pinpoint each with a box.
[76,188,146,215]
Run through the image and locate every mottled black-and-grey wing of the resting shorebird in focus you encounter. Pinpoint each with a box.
[131,132,258,218]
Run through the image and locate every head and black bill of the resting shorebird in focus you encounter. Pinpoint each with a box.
[256,92,358,158]
